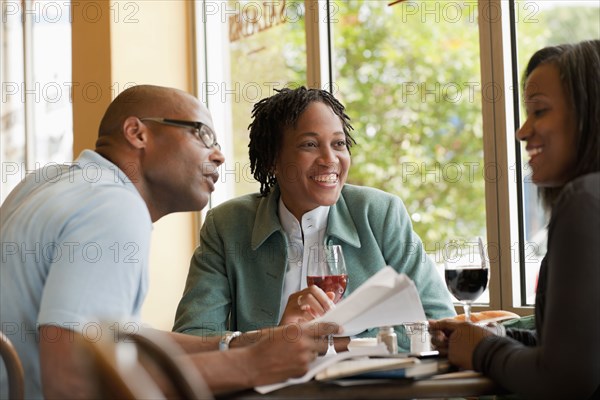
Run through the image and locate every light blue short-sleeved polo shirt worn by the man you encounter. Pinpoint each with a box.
[0,150,152,399]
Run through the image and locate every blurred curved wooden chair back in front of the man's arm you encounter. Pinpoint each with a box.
[84,330,213,400]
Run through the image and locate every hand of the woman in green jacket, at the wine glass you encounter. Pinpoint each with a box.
[279,285,335,325]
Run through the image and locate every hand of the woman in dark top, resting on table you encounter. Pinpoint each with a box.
[429,319,494,369]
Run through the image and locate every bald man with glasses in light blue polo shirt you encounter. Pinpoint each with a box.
[0,86,332,399]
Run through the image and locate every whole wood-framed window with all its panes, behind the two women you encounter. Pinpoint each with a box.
[197,0,600,314]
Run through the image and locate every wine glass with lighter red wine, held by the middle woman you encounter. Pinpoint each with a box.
[306,245,348,356]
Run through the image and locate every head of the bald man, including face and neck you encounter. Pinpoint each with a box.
[95,85,225,221]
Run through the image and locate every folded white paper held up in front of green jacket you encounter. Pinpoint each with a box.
[314,267,427,336]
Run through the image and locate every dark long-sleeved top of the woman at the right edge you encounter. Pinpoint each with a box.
[473,179,600,399]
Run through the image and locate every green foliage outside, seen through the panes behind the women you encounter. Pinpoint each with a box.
[229,0,600,252]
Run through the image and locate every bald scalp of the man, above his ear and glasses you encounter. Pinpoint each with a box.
[98,85,197,136]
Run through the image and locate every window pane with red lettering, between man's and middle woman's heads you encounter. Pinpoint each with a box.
[198,0,307,205]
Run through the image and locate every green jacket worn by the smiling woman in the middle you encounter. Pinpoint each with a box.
[174,185,455,344]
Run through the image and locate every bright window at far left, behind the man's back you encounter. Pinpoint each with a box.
[0,0,73,201]
